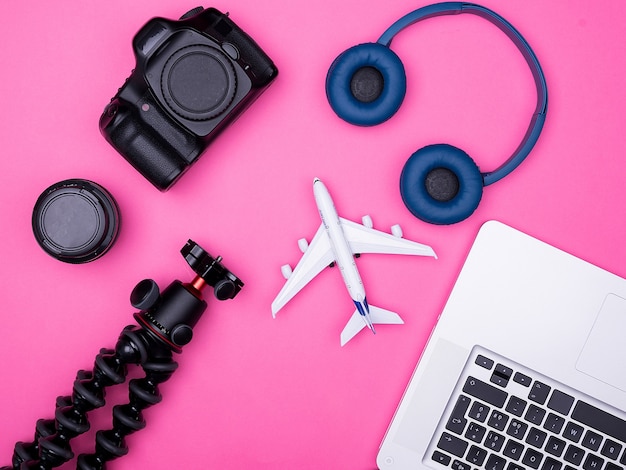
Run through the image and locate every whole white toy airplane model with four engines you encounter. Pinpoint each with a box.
[272,178,437,346]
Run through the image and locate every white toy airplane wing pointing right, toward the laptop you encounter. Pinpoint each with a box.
[340,217,437,258]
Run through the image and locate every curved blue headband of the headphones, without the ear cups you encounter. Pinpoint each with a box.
[377,2,548,186]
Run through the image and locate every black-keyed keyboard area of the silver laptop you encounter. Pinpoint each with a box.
[427,347,626,470]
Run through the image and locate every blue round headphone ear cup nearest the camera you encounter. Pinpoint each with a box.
[326,43,406,126]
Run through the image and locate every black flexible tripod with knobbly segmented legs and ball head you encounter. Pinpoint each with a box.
[0,240,243,470]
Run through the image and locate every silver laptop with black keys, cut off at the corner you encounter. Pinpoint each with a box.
[377,221,626,470]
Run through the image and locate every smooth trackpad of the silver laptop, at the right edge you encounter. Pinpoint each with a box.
[576,294,626,391]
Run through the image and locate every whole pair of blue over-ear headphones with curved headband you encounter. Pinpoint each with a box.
[326,2,548,224]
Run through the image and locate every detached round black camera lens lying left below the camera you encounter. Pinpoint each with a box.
[32,179,120,264]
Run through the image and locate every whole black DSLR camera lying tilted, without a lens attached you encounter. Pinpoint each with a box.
[100,7,278,191]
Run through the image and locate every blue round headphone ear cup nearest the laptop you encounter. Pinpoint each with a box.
[400,144,484,225]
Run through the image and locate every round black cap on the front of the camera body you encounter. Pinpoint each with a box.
[161,44,237,121]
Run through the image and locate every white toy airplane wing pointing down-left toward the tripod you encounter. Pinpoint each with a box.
[272,225,335,317]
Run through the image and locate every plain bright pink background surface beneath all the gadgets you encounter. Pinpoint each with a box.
[0,0,626,469]
